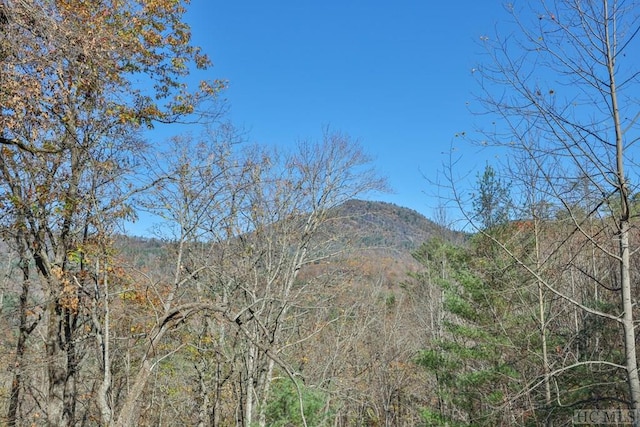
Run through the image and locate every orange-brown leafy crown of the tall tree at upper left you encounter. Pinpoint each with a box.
[0,0,222,143]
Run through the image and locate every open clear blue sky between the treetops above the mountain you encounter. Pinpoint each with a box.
[149,0,507,227]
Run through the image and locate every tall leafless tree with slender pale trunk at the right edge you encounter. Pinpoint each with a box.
[448,0,640,422]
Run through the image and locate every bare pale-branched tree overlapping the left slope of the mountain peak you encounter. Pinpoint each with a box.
[210,132,384,425]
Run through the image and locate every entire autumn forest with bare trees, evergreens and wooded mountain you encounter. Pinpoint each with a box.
[0,0,640,427]
